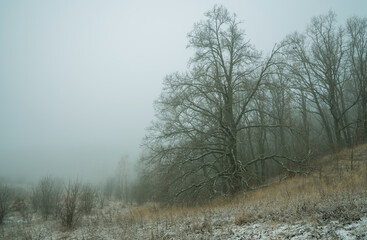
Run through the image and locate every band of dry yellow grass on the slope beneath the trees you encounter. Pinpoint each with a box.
[125,144,367,230]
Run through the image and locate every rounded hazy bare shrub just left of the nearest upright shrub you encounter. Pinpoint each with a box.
[31,177,61,219]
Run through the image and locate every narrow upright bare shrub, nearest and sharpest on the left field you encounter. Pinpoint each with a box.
[59,181,81,228]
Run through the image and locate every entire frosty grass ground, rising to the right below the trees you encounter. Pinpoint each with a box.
[0,145,367,239]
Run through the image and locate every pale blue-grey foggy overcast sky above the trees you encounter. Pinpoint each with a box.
[0,0,367,184]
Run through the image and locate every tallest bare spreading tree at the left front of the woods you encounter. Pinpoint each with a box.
[145,6,279,201]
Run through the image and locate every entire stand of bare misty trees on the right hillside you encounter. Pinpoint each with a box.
[135,6,367,202]
